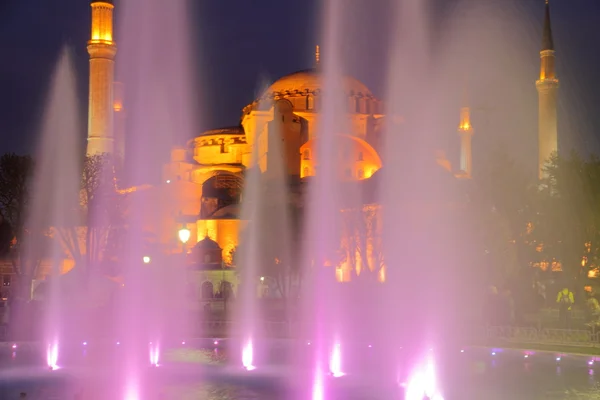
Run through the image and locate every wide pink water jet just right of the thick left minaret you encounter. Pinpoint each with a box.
[117,0,197,397]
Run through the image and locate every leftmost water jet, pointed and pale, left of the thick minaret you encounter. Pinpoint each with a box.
[22,49,81,369]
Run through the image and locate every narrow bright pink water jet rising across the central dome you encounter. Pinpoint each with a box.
[302,0,347,399]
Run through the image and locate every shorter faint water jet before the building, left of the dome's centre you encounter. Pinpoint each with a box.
[236,83,302,370]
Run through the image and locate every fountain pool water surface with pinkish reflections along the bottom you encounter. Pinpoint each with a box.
[0,339,600,400]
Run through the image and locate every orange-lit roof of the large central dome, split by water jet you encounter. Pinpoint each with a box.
[264,69,372,96]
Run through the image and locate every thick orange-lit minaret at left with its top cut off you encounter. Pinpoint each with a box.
[87,0,117,155]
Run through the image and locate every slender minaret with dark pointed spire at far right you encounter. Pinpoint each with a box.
[535,0,558,179]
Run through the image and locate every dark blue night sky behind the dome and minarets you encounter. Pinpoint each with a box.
[0,0,600,177]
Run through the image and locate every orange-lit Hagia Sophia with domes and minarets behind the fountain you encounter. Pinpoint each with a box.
[79,0,558,291]
